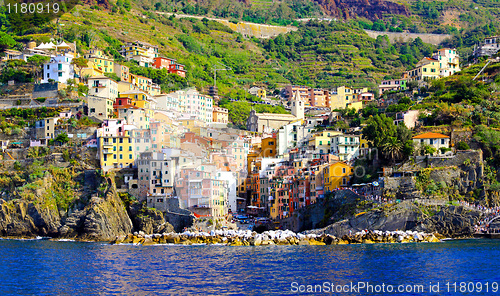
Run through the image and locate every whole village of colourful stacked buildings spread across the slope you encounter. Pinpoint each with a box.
[0,37,499,231]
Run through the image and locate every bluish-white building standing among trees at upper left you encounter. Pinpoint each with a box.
[42,53,75,83]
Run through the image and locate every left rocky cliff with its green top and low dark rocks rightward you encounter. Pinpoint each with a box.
[0,167,185,241]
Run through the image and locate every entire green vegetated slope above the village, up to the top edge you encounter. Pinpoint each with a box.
[0,0,498,100]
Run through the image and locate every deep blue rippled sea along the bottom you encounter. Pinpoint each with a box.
[0,239,500,295]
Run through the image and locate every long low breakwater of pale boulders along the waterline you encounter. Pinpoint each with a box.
[111,230,440,246]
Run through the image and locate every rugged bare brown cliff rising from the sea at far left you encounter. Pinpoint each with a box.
[0,171,132,241]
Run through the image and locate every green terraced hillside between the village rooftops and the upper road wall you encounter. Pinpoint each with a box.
[53,6,442,90]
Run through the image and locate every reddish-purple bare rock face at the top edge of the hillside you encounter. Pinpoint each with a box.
[314,0,410,20]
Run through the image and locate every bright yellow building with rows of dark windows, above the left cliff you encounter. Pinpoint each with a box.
[99,131,135,171]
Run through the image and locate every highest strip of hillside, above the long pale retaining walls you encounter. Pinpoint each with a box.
[132,0,500,33]
